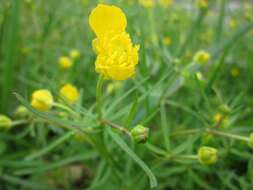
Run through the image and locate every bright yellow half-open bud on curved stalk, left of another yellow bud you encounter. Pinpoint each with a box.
[31,89,54,111]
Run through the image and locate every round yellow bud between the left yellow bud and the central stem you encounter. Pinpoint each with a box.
[60,84,79,104]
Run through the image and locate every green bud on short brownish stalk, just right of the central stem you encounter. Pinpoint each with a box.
[130,125,149,143]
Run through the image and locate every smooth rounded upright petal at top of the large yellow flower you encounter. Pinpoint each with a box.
[89,4,127,37]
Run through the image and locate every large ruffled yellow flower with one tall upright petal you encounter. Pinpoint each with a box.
[89,4,139,80]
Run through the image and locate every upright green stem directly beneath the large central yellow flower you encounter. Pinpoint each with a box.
[96,75,103,121]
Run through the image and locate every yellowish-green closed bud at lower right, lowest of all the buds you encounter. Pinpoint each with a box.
[198,146,218,165]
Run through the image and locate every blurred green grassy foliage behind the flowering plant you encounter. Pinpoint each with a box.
[0,0,253,190]
